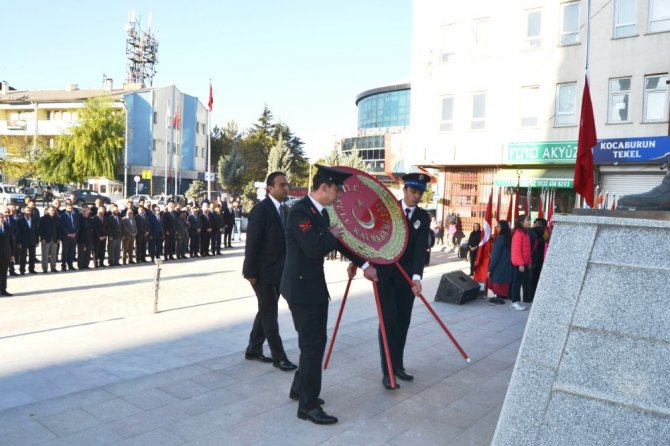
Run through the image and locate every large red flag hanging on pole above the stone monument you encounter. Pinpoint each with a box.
[574,76,598,208]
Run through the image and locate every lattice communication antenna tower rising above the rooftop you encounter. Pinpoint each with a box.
[126,10,158,87]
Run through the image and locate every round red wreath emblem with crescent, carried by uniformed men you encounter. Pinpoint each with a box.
[327,166,408,264]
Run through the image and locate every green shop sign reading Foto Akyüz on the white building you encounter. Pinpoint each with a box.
[506,141,577,164]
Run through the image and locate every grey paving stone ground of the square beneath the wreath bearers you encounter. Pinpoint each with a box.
[0,243,528,446]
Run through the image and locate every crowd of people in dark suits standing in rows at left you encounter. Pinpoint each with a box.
[0,194,242,296]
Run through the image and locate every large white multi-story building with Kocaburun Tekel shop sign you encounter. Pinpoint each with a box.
[410,0,670,226]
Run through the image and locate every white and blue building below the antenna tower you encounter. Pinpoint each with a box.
[0,80,208,193]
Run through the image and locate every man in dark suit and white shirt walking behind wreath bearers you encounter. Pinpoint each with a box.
[242,172,297,371]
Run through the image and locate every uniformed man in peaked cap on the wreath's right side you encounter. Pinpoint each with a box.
[368,173,430,389]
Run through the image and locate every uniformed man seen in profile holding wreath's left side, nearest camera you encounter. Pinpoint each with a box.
[280,165,377,424]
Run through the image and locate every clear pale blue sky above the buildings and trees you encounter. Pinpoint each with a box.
[0,0,412,159]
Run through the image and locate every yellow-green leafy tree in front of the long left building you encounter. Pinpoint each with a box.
[38,98,126,183]
